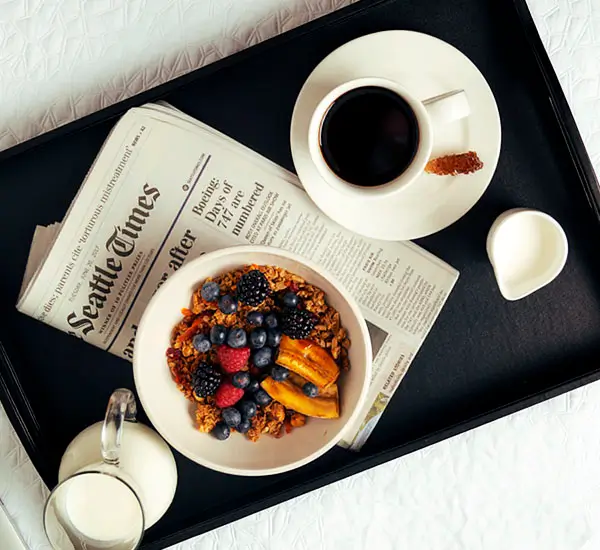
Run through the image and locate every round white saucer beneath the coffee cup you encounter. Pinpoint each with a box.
[290,31,501,241]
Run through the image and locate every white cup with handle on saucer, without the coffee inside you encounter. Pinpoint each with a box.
[308,77,470,199]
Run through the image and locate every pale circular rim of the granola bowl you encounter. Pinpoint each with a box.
[132,245,373,477]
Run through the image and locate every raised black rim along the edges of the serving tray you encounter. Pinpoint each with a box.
[0,0,600,550]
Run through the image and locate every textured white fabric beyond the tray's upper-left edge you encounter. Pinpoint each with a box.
[0,0,353,150]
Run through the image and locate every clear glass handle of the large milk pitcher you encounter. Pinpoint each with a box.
[101,388,137,466]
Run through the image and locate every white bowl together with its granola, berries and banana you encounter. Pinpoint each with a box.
[134,246,371,475]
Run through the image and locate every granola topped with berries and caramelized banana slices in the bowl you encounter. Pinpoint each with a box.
[166,264,350,441]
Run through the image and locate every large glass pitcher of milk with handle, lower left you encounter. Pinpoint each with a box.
[44,389,177,550]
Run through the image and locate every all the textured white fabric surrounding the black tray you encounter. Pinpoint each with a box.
[0,0,600,550]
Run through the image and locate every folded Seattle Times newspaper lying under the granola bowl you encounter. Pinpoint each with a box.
[17,103,458,450]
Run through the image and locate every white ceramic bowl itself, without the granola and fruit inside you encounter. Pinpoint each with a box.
[133,246,371,476]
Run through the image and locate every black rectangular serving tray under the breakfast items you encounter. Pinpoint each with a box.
[0,0,600,549]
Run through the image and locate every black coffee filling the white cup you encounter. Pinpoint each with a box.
[321,86,419,187]
